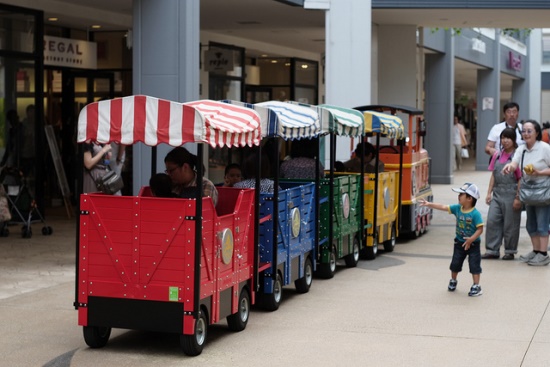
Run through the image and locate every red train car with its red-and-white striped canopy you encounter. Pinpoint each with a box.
[75,96,260,355]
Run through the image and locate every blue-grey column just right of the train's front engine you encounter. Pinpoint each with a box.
[424,31,454,184]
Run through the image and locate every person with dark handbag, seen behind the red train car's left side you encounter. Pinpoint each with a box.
[82,143,111,194]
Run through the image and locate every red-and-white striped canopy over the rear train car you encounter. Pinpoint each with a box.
[77,96,261,147]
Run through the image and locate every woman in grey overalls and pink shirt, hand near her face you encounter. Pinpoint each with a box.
[481,128,521,260]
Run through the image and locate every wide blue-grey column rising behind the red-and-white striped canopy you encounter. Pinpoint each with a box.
[133,0,200,194]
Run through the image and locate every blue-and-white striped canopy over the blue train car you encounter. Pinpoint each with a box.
[223,100,321,140]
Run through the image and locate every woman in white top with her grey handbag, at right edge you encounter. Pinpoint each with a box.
[502,120,550,266]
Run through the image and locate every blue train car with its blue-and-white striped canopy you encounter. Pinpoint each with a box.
[224,101,320,311]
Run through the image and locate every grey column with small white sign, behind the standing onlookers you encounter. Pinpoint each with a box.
[475,35,504,171]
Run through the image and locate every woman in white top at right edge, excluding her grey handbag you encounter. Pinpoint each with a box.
[503,120,550,266]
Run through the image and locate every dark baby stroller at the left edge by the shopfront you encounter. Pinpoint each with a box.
[0,167,53,238]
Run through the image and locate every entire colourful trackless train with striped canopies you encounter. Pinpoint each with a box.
[74,96,432,356]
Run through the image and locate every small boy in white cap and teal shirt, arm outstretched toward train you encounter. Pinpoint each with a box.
[420,183,483,297]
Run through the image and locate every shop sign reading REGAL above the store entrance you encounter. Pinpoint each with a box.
[44,36,97,69]
